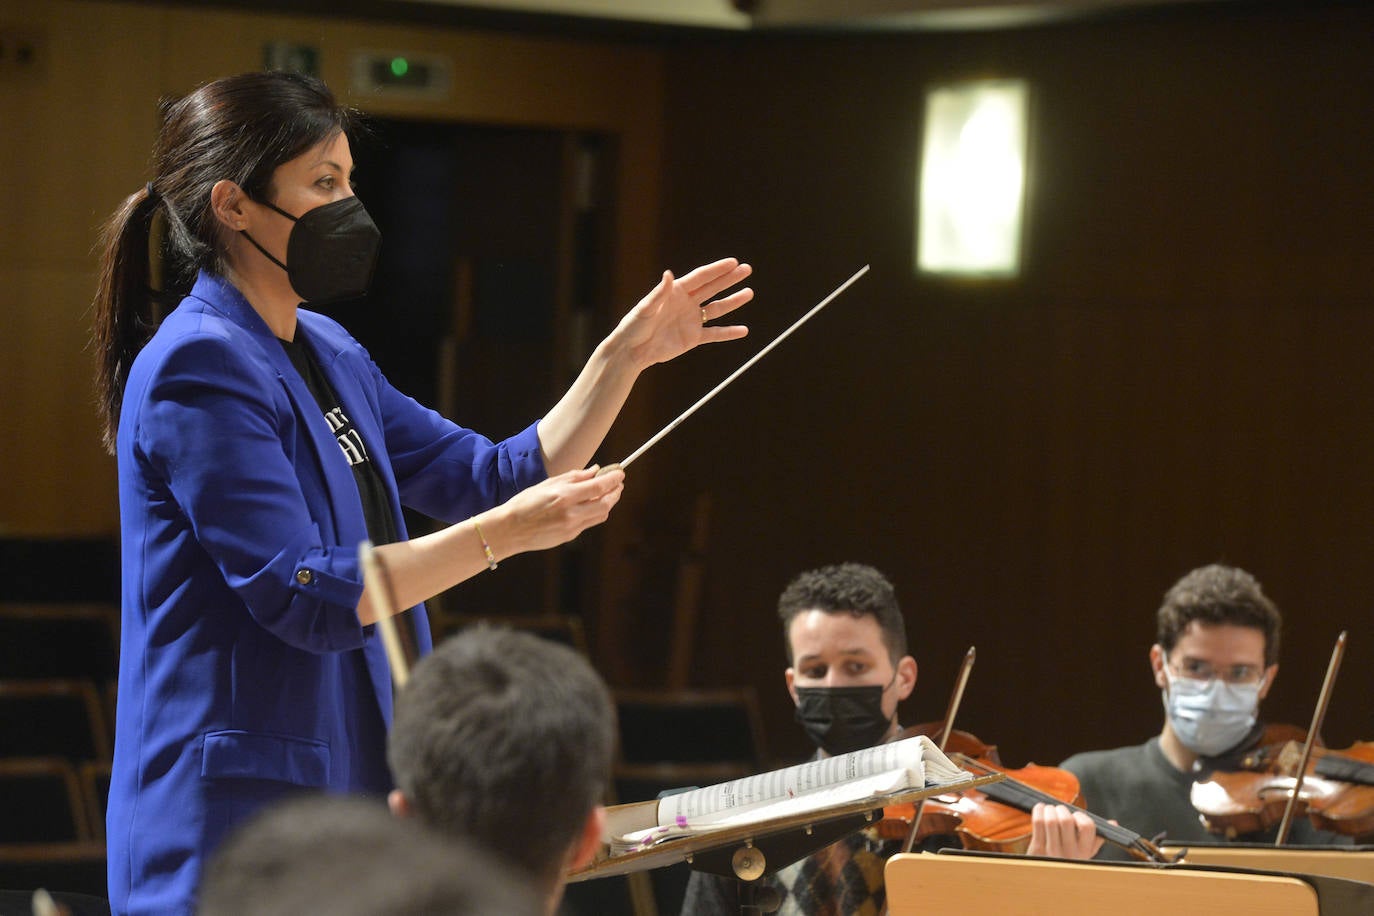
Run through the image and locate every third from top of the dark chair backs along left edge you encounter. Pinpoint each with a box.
[0,678,110,761]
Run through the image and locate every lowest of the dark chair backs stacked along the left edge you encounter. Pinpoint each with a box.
[0,757,92,845]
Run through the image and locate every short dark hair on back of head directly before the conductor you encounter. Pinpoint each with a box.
[386,625,616,887]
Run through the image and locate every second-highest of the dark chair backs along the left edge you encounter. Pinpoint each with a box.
[0,603,120,681]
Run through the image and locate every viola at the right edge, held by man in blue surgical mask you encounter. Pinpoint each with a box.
[1191,725,1374,839]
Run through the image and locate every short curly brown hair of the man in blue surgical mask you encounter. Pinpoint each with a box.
[1154,563,1283,665]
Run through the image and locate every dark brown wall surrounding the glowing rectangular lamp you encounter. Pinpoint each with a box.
[632,4,1374,764]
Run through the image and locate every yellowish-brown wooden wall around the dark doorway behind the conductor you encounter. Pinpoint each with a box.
[0,0,662,552]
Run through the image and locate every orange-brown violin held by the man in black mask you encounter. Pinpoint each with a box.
[871,722,1169,862]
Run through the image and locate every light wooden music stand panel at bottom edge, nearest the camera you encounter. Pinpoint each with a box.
[883,853,1319,916]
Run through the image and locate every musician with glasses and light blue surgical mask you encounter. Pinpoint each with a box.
[1061,564,1349,858]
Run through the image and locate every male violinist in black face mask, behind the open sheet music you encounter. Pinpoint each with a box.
[682,563,1102,916]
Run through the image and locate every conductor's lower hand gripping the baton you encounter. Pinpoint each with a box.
[484,467,625,559]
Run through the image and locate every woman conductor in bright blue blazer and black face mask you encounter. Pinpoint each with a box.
[95,73,753,913]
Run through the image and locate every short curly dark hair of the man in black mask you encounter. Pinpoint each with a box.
[778,563,907,665]
